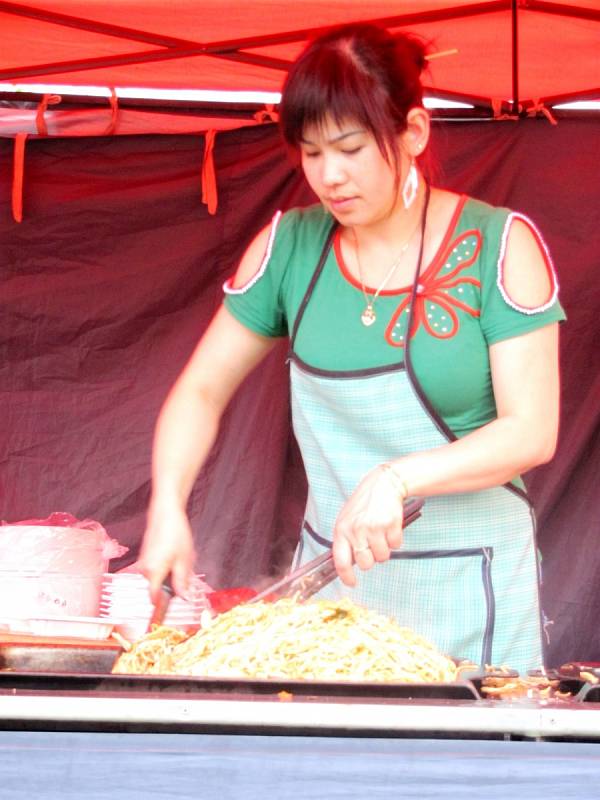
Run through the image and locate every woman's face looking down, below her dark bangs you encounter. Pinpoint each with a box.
[300,118,404,226]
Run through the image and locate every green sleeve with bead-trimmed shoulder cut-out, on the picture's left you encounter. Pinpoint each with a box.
[223,211,293,337]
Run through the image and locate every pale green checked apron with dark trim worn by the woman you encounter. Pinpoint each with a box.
[290,227,543,672]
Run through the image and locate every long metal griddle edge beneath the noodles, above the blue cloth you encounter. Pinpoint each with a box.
[0,672,600,741]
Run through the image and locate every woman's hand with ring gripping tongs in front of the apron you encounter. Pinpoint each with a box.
[333,466,403,586]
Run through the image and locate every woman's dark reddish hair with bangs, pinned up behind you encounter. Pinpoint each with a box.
[279,23,426,163]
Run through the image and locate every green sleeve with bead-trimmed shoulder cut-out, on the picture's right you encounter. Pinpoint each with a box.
[481,209,565,344]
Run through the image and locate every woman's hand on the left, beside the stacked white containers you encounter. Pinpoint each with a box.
[138,504,194,602]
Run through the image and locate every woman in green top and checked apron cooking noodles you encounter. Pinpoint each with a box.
[141,24,563,670]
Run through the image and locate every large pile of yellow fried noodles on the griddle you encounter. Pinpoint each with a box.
[113,598,457,683]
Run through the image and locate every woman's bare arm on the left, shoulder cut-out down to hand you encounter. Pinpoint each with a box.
[138,227,277,600]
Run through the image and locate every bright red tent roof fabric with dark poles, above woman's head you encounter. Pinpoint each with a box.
[0,0,600,109]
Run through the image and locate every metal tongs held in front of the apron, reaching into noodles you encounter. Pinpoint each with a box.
[248,497,424,603]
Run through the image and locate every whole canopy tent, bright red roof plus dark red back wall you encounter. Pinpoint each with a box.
[0,0,600,663]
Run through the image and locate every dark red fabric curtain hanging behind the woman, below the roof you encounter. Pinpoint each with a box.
[0,119,600,664]
